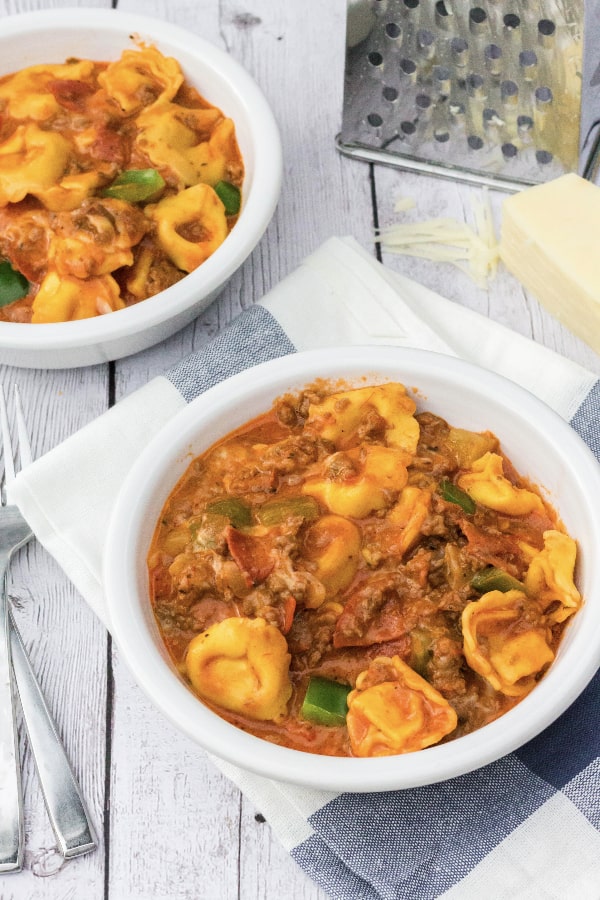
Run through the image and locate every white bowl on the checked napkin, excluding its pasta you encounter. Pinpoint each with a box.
[104,347,600,791]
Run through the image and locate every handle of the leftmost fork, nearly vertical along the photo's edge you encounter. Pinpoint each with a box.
[0,568,25,875]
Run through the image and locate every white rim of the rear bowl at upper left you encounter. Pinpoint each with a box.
[0,7,283,352]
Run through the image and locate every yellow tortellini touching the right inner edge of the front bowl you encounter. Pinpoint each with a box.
[525,531,581,622]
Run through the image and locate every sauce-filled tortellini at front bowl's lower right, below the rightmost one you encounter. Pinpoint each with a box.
[462,590,554,697]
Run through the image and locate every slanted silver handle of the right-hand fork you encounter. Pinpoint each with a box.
[8,610,96,859]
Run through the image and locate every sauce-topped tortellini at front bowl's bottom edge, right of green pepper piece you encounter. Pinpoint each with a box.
[347,656,458,757]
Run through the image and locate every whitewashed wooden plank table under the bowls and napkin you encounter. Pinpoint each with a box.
[0,0,600,900]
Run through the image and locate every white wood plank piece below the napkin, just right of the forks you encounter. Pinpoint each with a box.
[108,654,240,900]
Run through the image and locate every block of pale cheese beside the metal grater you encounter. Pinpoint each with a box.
[500,174,600,353]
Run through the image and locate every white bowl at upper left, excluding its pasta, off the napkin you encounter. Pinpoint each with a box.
[0,8,282,369]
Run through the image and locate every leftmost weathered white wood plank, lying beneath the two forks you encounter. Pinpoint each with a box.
[0,366,107,900]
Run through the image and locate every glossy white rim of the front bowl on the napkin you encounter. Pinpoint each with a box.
[103,345,600,792]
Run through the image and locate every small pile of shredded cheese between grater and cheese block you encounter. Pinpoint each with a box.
[375,191,499,288]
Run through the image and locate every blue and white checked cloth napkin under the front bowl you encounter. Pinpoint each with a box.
[11,238,600,900]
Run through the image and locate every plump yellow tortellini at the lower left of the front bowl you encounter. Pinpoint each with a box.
[185,618,292,721]
